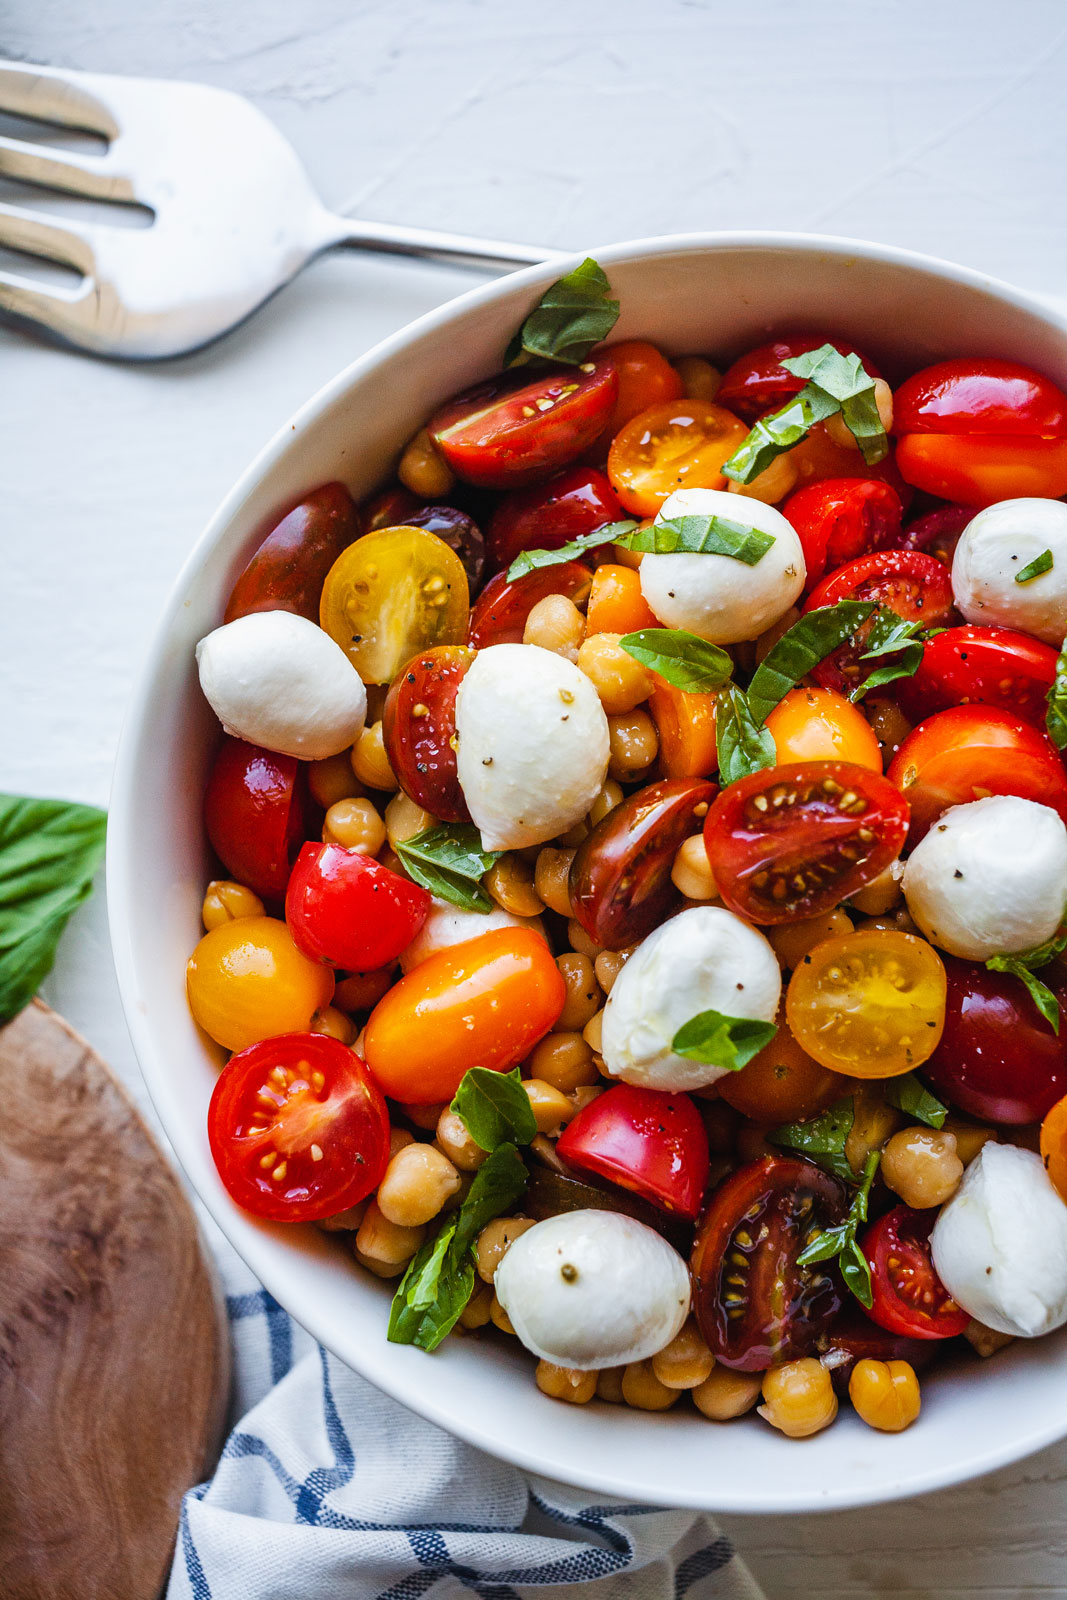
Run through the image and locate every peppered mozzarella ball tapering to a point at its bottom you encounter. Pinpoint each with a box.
[456,645,609,850]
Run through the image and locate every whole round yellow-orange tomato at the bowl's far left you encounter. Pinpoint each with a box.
[186,917,334,1050]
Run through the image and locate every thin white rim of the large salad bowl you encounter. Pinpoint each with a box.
[107,229,1067,1515]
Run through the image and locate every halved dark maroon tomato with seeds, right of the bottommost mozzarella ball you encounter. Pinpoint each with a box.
[689,1155,848,1373]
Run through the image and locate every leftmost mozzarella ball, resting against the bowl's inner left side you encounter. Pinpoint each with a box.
[197,611,366,762]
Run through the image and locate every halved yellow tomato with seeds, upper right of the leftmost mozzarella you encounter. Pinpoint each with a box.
[318,528,470,683]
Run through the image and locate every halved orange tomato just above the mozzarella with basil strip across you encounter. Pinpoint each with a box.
[608,400,749,517]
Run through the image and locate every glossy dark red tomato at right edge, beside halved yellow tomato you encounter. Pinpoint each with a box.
[923,955,1067,1126]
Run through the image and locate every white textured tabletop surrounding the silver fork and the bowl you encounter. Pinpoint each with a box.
[0,0,1067,1600]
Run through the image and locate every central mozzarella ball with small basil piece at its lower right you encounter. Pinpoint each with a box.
[601,906,782,1093]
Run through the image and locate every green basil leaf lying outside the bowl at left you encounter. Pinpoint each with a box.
[0,795,107,1022]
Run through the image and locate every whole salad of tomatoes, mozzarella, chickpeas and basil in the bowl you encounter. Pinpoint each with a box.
[187,261,1067,1437]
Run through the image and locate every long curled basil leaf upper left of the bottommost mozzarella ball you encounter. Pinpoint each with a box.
[387,1144,528,1350]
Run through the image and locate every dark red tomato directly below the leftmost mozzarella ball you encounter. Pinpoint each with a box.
[203,738,322,901]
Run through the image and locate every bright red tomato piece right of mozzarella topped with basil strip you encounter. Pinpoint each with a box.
[782,477,904,589]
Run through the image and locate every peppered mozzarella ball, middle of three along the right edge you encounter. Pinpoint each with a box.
[902,795,1067,962]
